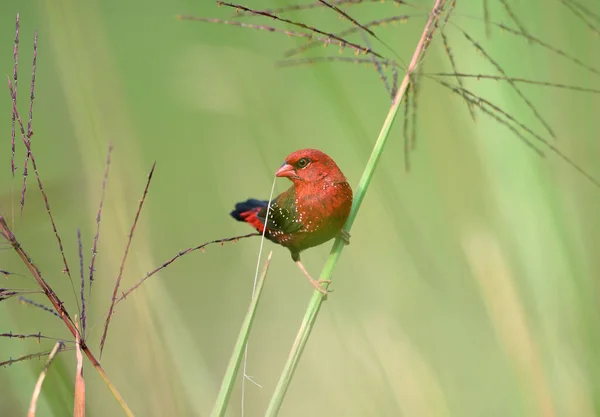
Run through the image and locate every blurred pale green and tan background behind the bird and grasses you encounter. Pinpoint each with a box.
[0,0,600,417]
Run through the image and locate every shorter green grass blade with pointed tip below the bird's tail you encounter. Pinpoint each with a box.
[210,251,273,417]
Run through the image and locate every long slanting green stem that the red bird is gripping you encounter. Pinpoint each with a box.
[265,0,445,417]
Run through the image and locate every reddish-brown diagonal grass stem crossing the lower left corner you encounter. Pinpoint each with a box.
[0,214,133,416]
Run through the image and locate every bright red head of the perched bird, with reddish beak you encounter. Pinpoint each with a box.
[275,149,346,185]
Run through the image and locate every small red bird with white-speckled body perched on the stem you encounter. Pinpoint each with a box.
[231,149,352,294]
